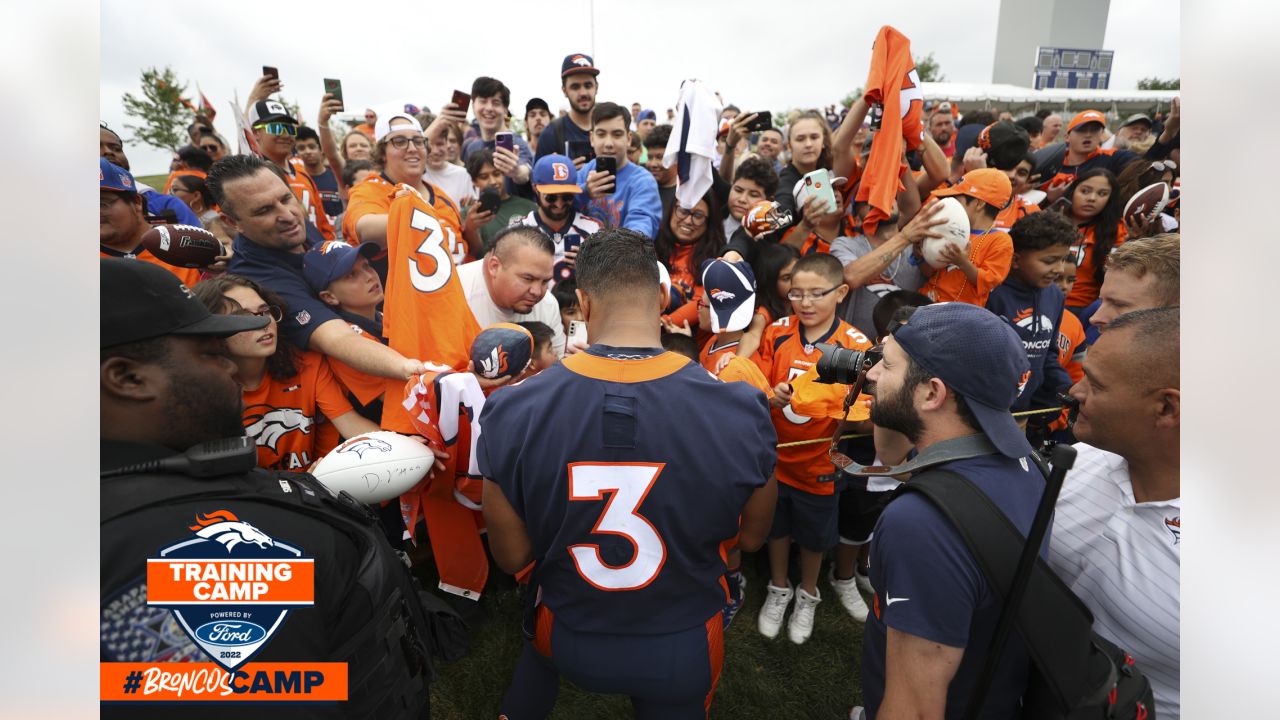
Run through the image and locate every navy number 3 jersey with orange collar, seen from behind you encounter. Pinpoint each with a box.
[476,345,777,634]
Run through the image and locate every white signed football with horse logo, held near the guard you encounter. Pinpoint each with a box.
[311,430,435,503]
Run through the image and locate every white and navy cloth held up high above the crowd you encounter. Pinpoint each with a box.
[662,79,723,210]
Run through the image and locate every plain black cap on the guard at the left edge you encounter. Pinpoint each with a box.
[99,258,269,347]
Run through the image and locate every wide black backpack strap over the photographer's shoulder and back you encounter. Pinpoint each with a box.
[896,469,1110,708]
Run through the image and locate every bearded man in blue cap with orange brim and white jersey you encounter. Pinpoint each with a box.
[518,154,603,283]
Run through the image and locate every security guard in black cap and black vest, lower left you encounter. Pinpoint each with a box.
[100,259,431,720]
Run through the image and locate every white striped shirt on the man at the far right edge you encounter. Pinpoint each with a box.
[1050,443,1181,720]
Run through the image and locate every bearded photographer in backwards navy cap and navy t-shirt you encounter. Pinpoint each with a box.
[854,302,1047,717]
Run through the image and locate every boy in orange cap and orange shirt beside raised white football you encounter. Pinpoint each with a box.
[913,168,1014,307]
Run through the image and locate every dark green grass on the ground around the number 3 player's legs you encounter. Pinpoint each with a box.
[420,550,863,720]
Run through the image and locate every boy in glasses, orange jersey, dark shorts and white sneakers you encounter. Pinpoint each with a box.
[751,253,870,644]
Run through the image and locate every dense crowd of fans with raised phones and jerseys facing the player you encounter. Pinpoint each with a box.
[100,46,1180,717]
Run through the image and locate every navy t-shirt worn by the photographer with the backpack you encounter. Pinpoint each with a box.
[861,455,1050,719]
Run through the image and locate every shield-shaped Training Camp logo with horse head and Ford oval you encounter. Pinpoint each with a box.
[146,510,315,671]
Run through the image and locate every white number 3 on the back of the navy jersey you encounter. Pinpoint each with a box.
[568,462,667,591]
